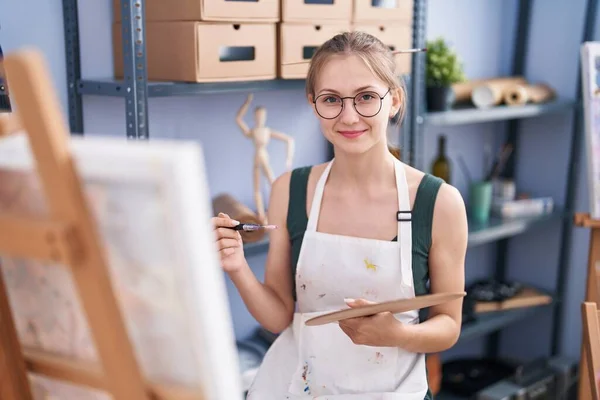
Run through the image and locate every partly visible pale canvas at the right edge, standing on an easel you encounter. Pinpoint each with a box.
[581,42,600,219]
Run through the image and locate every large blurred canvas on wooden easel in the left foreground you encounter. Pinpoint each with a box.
[0,50,242,400]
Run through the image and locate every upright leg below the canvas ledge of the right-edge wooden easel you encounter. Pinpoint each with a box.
[578,228,600,400]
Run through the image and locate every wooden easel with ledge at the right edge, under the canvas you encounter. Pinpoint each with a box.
[574,213,600,400]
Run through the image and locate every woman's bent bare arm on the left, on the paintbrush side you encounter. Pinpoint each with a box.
[225,172,294,333]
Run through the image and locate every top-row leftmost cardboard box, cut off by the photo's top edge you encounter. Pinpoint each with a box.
[113,0,280,22]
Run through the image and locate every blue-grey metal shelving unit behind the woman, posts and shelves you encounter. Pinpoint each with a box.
[58,0,598,396]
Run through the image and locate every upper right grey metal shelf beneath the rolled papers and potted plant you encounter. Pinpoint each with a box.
[425,99,577,126]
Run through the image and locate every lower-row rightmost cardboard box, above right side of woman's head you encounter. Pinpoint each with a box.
[352,22,412,74]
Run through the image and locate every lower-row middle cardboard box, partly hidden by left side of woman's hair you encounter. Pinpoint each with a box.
[278,22,351,79]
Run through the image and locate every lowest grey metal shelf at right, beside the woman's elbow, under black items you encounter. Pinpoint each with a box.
[458,300,556,343]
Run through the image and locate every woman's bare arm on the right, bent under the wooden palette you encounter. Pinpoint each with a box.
[399,184,468,353]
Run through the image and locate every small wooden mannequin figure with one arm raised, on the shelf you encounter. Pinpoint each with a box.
[236,93,294,223]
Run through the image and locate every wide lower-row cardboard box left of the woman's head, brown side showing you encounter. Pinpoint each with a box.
[113,21,277,82]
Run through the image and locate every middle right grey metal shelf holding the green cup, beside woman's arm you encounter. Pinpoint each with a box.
[468,211,567,247]
